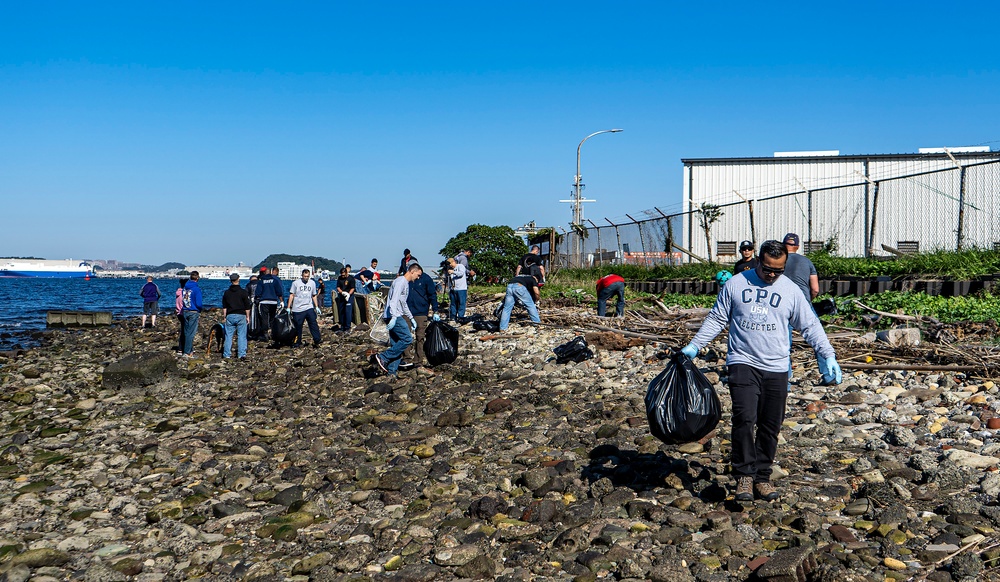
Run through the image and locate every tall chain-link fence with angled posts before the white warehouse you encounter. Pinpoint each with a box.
[549,161,1000,268]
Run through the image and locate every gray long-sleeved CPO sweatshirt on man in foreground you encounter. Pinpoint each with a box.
[691,270,835,372]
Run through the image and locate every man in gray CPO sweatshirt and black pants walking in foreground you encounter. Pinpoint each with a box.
[681,241,841,501]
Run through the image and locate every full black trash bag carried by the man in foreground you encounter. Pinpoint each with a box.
[646,352,722,445]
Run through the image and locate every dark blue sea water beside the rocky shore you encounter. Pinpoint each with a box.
[0,278,300,350]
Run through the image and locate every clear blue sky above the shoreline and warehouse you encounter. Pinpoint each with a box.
[0,1,1000,264]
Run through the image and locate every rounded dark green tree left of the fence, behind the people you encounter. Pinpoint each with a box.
[438,224,528,278]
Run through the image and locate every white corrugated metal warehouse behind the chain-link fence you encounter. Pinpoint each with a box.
[680,147,1000,261]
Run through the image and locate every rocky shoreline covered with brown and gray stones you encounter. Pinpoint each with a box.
[0,307,1000,582]
